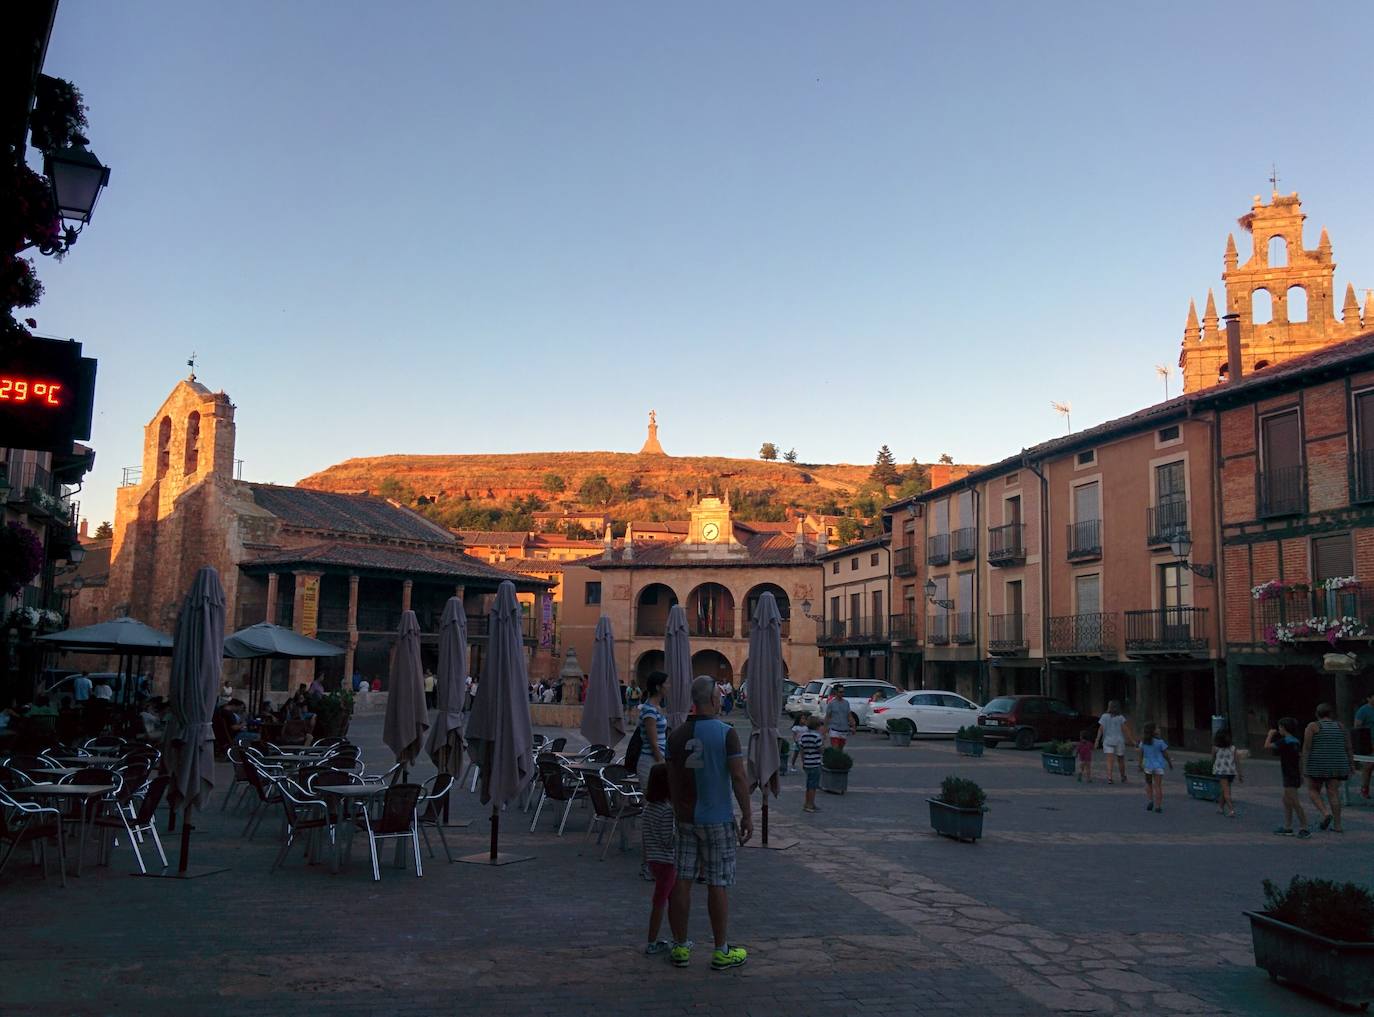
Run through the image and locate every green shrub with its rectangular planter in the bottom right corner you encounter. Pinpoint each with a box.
[1245,875,1374,1006]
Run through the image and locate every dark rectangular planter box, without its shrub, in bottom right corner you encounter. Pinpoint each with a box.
[1245,911,1374,1006]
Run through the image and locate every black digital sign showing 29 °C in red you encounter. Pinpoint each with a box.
[0,338,96,452]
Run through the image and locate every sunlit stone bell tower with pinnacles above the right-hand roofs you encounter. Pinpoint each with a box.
[1179,191,1374,392]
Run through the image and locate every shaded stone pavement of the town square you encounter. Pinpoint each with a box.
[0,717,1374,1017]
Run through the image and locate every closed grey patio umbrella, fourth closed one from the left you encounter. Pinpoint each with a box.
[462,580,534,864]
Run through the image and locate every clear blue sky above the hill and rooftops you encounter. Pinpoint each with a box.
[37,0,1374,525]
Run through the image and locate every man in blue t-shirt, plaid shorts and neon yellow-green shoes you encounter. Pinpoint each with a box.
[668,676,754,970]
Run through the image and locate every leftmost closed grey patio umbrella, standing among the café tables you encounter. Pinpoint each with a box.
[164,565,224,877]
